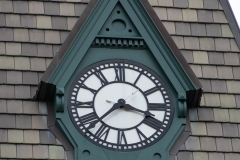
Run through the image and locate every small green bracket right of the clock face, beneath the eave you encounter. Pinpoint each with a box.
[178,93,187,118]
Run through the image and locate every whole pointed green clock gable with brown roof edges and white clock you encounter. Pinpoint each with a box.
[35,0,202,160]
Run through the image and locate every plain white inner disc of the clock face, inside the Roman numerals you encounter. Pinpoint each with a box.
[94,83,147,129]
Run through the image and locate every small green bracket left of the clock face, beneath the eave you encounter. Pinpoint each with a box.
[55,87,64,112]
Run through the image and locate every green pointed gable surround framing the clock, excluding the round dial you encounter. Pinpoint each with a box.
[36,0,201,160]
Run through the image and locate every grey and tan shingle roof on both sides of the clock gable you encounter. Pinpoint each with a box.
[0,0,240,160]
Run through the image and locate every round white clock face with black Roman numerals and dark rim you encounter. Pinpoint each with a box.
[68,59,174,152]
